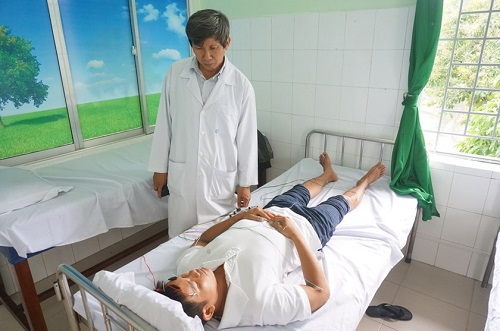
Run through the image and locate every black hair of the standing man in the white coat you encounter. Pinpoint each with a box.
[186,9,229,47]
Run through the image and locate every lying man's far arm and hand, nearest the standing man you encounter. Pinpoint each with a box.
[192,208,275,246]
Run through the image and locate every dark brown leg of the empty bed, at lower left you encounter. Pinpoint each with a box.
[14,259,47,331]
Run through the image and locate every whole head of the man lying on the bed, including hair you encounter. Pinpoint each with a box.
[160,268,218,323]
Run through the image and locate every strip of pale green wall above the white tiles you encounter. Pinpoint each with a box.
[191,0,417,19]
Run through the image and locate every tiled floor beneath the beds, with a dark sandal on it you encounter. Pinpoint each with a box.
[0,261,491,331]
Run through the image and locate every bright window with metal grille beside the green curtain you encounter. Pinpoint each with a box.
[419,0,500,162]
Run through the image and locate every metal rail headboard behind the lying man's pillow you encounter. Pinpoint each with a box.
[54,264,156,331]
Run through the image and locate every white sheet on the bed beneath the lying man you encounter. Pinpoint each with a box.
[74,159,417,331]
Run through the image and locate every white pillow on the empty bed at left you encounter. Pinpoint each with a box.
[0,166,73,214]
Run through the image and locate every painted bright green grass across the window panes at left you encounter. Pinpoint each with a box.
[0,94,160,159]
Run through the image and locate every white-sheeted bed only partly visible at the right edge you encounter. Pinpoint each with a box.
[482,228,500,331]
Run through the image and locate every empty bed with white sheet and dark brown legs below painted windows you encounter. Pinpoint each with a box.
[0,136,167,331]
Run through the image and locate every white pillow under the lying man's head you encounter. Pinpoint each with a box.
[93,270,204,331]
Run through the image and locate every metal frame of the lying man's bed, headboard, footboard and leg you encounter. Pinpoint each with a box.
[54,130,421,331]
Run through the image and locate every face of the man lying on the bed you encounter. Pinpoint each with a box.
[166,268,217,304]
